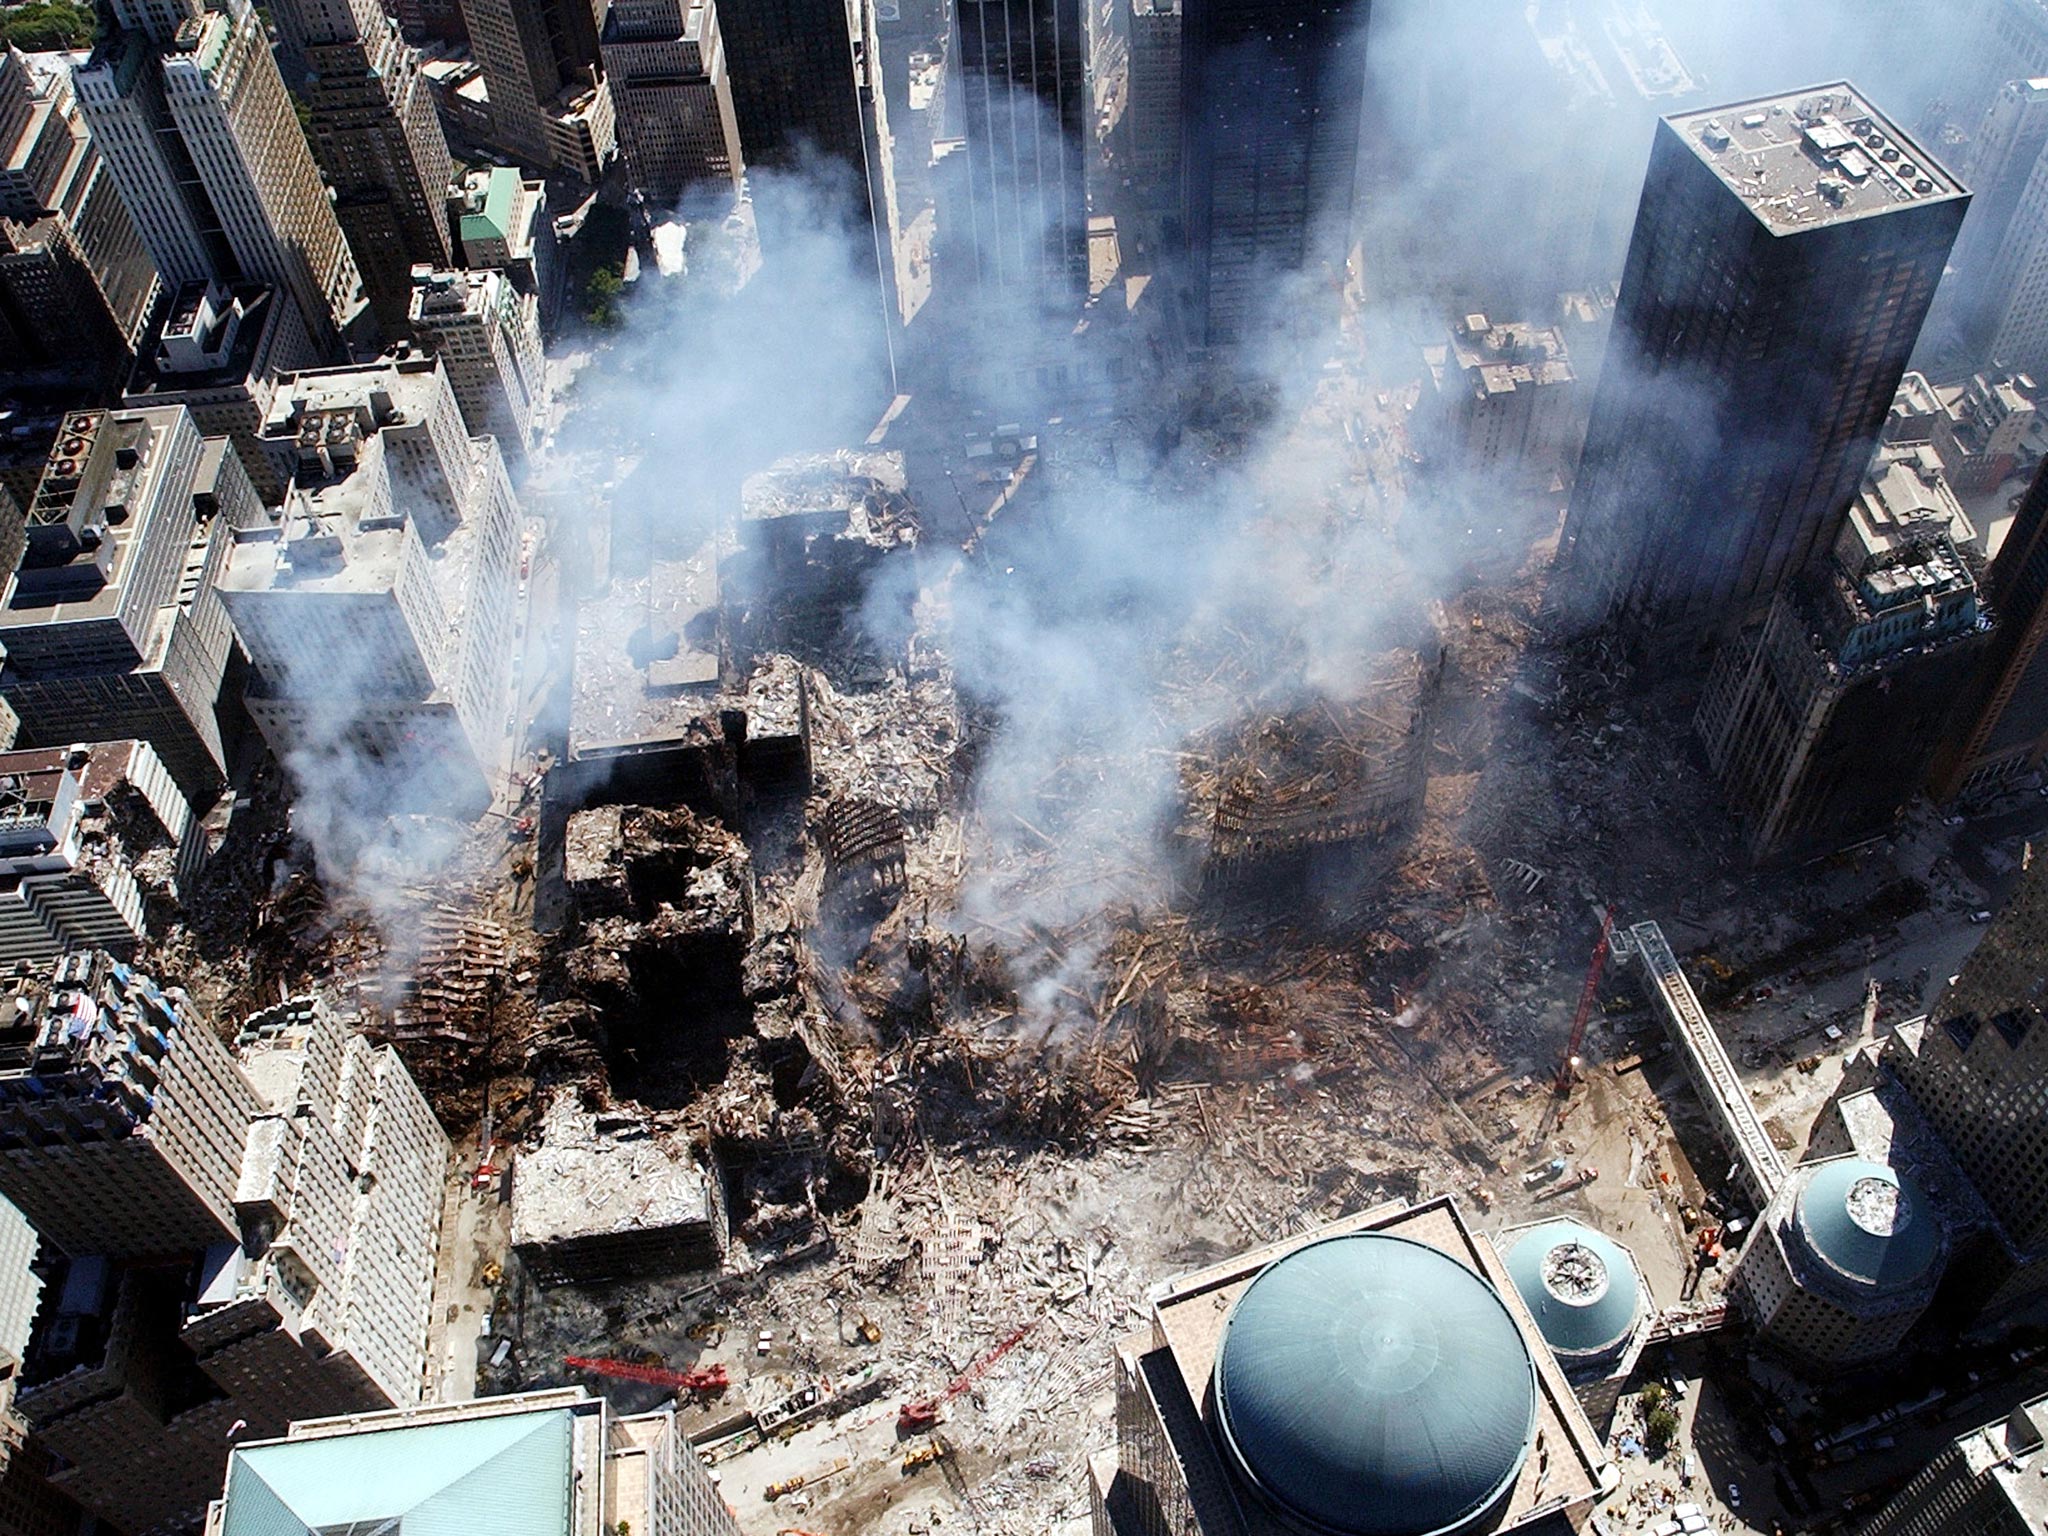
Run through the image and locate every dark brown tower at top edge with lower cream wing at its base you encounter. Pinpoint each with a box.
[463,0,616,180]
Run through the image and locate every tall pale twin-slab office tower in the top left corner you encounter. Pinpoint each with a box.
[74,0,362,346]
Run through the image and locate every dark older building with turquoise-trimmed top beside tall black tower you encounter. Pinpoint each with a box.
[1696,451,1993,860]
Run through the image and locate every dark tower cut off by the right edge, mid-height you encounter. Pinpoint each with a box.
[1929,450,2048,801]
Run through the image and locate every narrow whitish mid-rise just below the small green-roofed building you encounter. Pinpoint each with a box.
[412,266,547,463]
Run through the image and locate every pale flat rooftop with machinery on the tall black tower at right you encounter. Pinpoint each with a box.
[1665,80,1968,236]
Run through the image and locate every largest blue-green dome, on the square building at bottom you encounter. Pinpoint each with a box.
[1214,1233,1536,1536]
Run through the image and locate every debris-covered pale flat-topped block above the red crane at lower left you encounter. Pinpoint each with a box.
[512,1090,727,1286]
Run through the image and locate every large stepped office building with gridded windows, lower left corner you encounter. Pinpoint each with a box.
[0,954,449,1530]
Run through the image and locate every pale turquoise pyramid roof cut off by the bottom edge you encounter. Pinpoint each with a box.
[221,1407,573,1536]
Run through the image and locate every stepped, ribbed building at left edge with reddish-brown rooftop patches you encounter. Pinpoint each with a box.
[0,741,203,965]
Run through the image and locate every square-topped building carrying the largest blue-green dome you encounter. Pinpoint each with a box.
[1090,1198,1618,1536]
